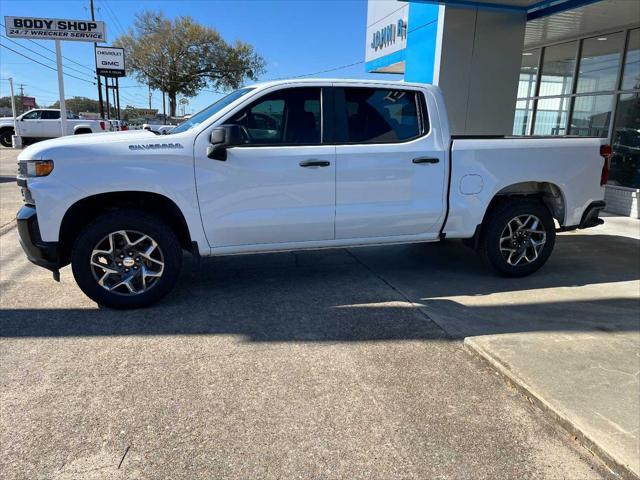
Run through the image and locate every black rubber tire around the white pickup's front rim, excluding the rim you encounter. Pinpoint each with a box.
[71,210,182,309]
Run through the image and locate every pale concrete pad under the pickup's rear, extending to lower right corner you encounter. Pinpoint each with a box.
[356,215,640,478]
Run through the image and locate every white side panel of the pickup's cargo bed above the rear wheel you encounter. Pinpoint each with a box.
[443,135,606,238]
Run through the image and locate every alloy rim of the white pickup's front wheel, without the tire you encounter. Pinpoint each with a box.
[90,230,164,296]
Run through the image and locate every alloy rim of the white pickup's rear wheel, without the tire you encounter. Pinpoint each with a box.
[500,215,547,266]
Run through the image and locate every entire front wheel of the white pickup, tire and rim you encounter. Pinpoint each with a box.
[71,210,182,309]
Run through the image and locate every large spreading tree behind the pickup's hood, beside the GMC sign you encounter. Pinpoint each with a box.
[114,11,265,116]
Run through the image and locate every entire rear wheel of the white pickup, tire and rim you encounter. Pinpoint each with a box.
[478,199,556,277]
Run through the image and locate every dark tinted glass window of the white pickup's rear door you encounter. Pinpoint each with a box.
[336,87,428,143]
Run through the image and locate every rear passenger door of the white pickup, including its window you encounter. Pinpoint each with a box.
[335,84,446,239]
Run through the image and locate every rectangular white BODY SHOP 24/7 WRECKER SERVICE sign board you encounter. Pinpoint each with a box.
[4,17,107,42]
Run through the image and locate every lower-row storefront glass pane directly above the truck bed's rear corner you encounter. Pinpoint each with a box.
[569,95,613,138]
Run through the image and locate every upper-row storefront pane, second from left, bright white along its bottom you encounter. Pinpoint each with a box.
[540,42,578,97]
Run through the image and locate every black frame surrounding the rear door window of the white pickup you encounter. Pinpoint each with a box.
[332,85,431,145]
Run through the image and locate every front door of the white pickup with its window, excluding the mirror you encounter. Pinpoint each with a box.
[195,86,336,248]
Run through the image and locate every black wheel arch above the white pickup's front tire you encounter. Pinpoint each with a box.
[58,191,192,265]
